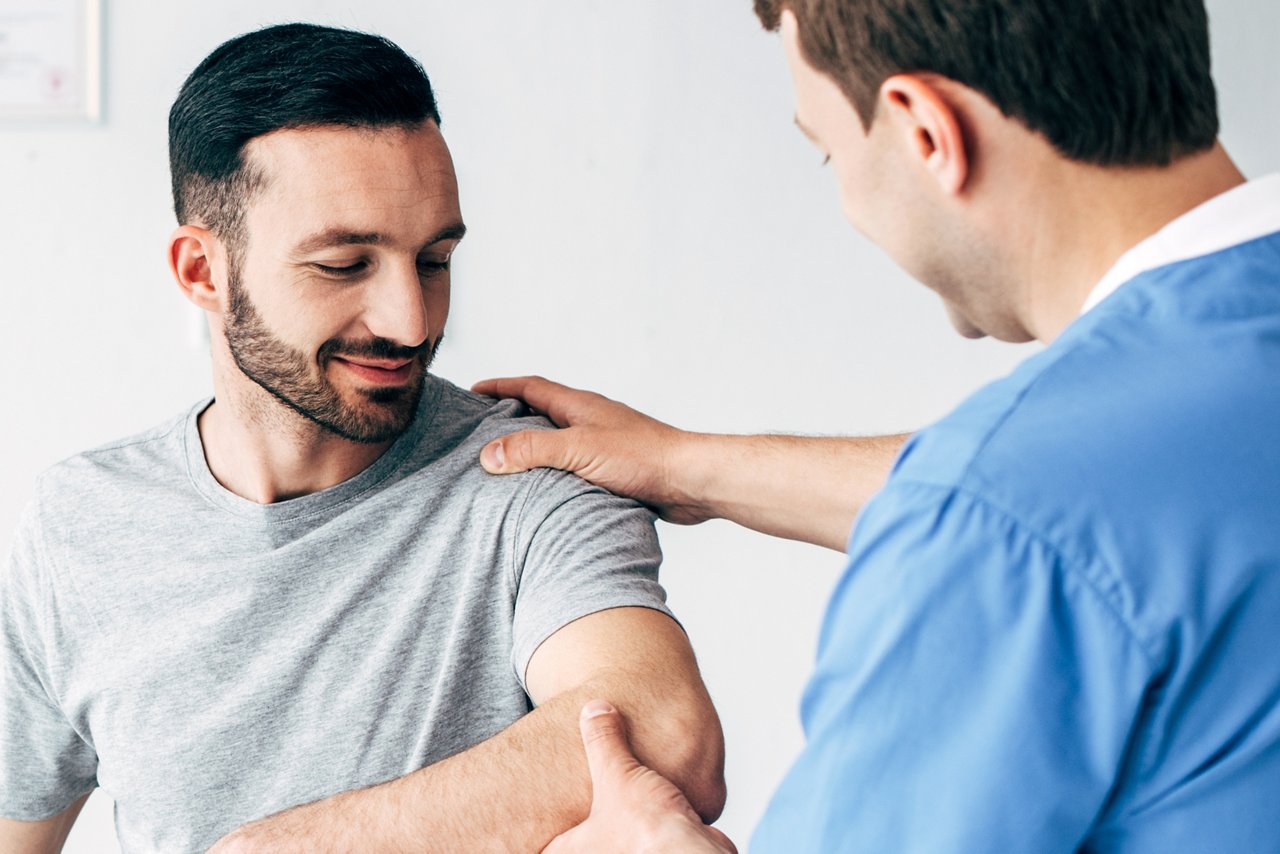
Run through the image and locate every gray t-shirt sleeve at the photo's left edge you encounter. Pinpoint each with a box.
[0,508,97,821]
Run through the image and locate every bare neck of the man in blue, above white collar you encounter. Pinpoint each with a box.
[1018,145,1244,343]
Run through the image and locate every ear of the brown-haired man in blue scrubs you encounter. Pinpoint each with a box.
[878,74,969,196]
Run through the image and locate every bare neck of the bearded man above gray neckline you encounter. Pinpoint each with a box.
[197,371,393,504]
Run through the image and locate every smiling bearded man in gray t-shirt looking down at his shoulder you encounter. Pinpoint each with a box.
[0,24,724,851]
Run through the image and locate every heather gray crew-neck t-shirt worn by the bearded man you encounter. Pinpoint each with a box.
[0,378,666,851]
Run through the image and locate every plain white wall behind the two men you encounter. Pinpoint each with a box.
[0,0,1280,853]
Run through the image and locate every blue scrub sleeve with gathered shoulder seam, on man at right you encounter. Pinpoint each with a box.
[751,483,1153,854]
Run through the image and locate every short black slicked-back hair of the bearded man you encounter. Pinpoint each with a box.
[169,23,440,245]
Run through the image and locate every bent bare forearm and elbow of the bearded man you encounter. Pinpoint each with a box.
[216,671,723,851]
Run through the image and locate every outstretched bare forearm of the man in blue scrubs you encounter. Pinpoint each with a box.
[673,434,910,551]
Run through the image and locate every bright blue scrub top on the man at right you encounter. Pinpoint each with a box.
[751,233,1280,854]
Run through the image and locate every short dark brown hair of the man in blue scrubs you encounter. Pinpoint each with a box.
[755,0,1219,166]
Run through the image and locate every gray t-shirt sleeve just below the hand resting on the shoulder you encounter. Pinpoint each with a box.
[511,469,671,685]
